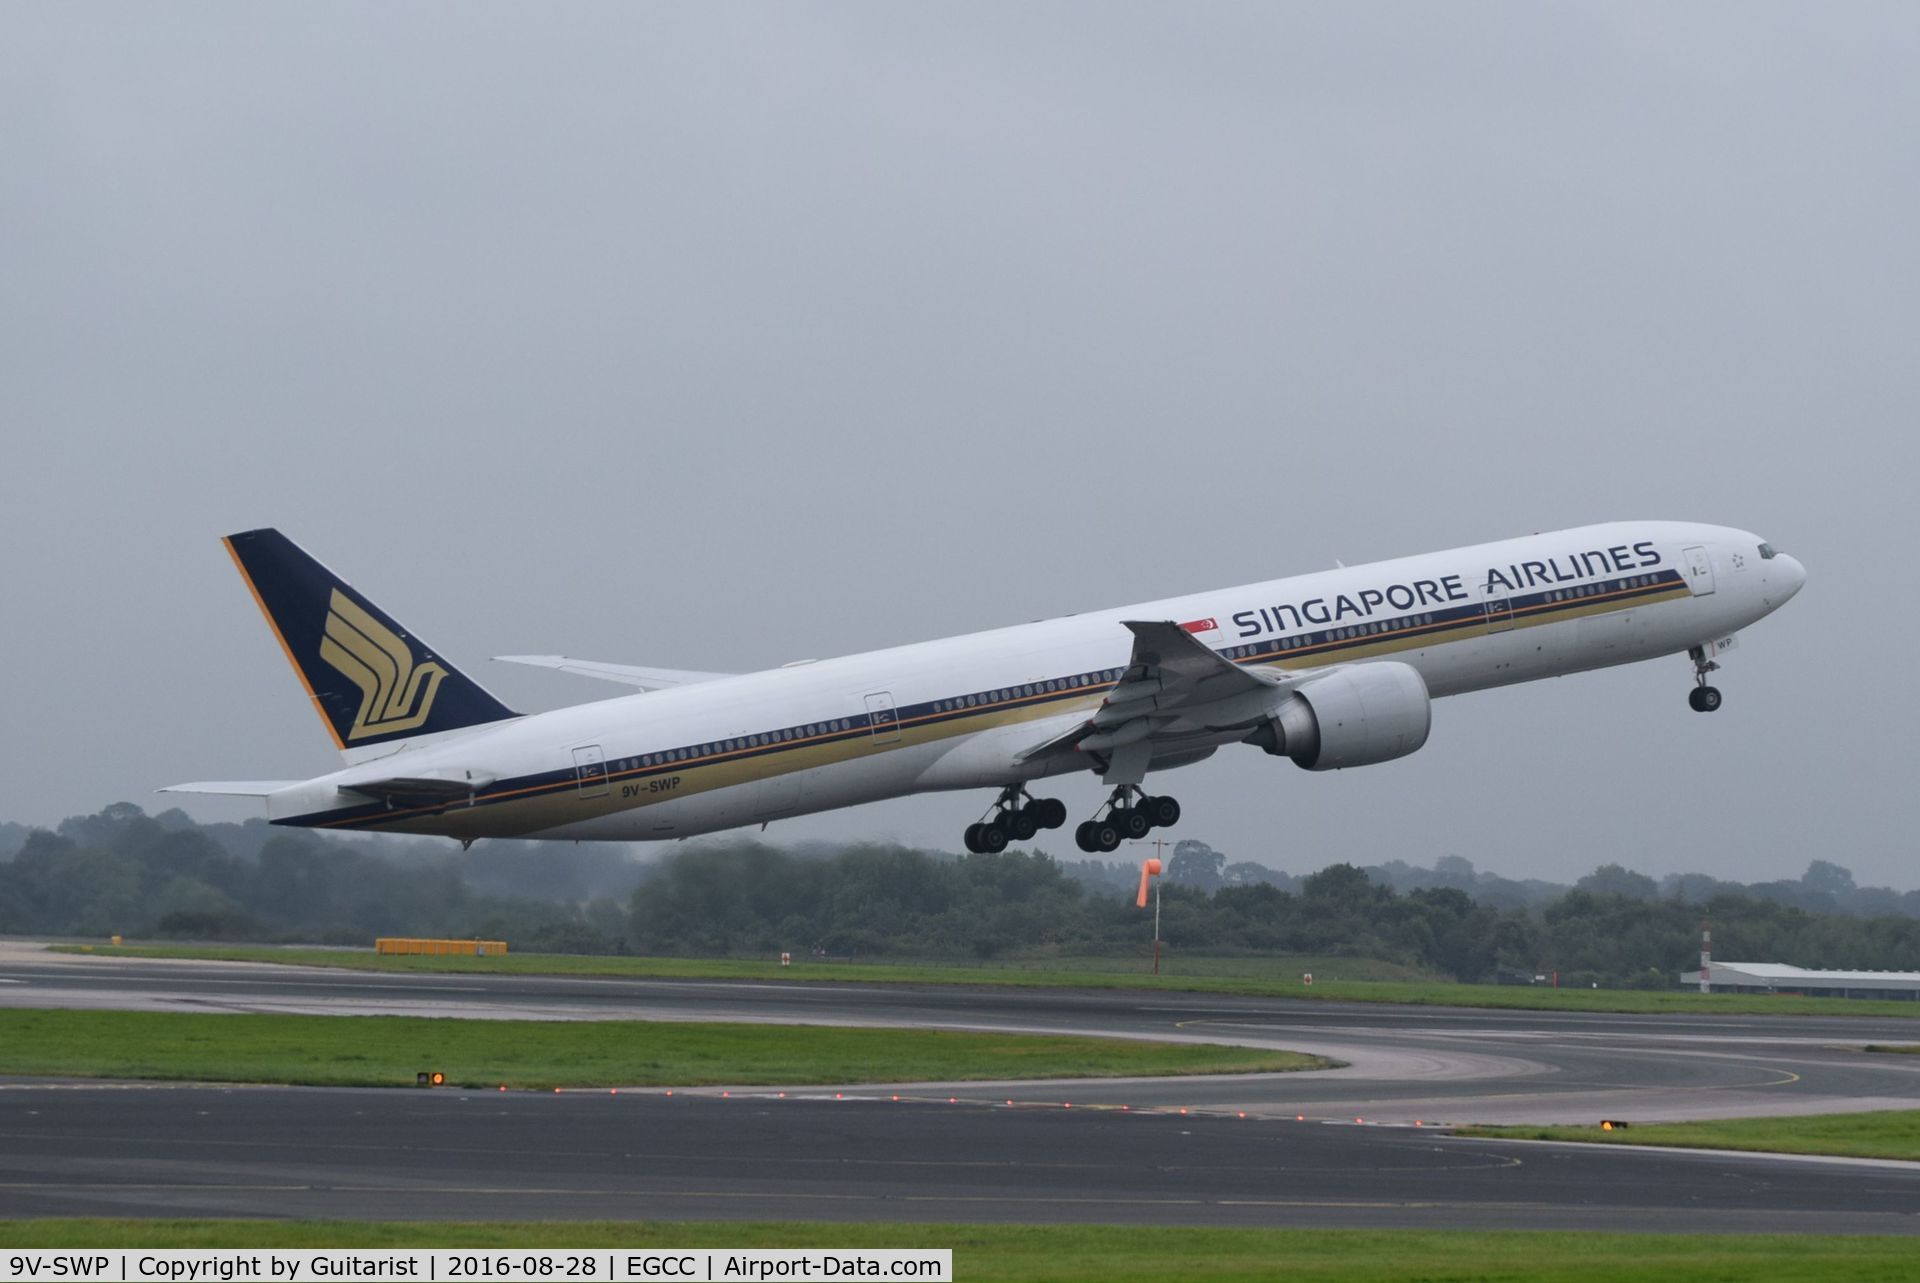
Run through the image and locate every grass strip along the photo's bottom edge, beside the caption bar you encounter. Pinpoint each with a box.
[0,1220,1920,1283]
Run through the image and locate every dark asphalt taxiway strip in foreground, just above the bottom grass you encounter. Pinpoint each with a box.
[0,1087,1920,1233]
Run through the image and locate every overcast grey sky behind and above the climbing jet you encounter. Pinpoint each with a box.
[0,2,1920,889]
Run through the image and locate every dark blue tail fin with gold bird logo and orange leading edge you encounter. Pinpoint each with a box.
[225,530,516,757]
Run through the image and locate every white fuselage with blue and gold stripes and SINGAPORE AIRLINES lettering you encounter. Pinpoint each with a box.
[269,520,1805,839]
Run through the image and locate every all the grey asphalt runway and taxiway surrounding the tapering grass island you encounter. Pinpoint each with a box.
[0,945,1920,1233]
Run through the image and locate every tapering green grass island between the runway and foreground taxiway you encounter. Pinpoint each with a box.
[0,1010,1327,1087]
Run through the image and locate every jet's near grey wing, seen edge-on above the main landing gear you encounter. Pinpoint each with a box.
[1020,620,1294,770]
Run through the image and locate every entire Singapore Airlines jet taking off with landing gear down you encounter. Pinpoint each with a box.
[169,520,1807,851]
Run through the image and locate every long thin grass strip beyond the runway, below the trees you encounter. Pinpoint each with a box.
[45,945,1920,1018]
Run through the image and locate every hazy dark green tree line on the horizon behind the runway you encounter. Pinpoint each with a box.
[0,803,1920,989]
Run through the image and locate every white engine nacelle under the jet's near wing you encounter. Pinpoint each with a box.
[1252,663,1432,770]
